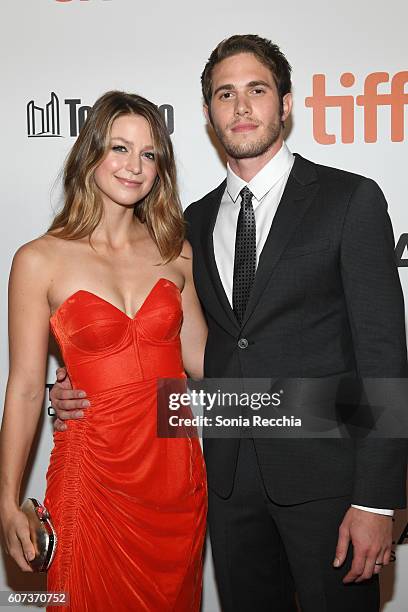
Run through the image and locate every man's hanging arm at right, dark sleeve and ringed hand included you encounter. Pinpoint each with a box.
[334,179,407,582]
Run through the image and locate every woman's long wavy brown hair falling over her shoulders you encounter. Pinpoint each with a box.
[48,91,185,262]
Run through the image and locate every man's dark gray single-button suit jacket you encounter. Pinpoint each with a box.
[185,155,408,508]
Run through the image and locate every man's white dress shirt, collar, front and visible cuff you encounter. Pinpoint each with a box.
[213,143,393,516]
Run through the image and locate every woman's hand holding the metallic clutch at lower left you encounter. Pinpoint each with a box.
[1,506,35,572]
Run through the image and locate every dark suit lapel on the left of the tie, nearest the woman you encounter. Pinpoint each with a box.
[201,180,239,334]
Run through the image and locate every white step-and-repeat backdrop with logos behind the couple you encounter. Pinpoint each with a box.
[0,0,408,612]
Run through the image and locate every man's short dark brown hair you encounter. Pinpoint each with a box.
[201,34,292,107]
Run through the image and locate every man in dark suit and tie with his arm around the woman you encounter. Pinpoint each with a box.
[53,35,407,612]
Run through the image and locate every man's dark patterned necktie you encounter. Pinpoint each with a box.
[232,187,256,323]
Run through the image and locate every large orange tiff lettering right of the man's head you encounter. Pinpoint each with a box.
[305,70,408,144]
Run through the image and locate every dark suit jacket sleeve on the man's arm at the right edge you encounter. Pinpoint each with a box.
[341,179,408,508]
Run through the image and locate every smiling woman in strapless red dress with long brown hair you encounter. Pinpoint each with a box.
[0,92,206,612]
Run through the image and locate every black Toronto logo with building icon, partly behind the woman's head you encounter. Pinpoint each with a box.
[27,91,174,138]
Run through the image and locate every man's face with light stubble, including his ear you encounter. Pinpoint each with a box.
[204,53,292,159]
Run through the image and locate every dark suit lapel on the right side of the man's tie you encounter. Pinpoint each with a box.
[242,155,319,325]
